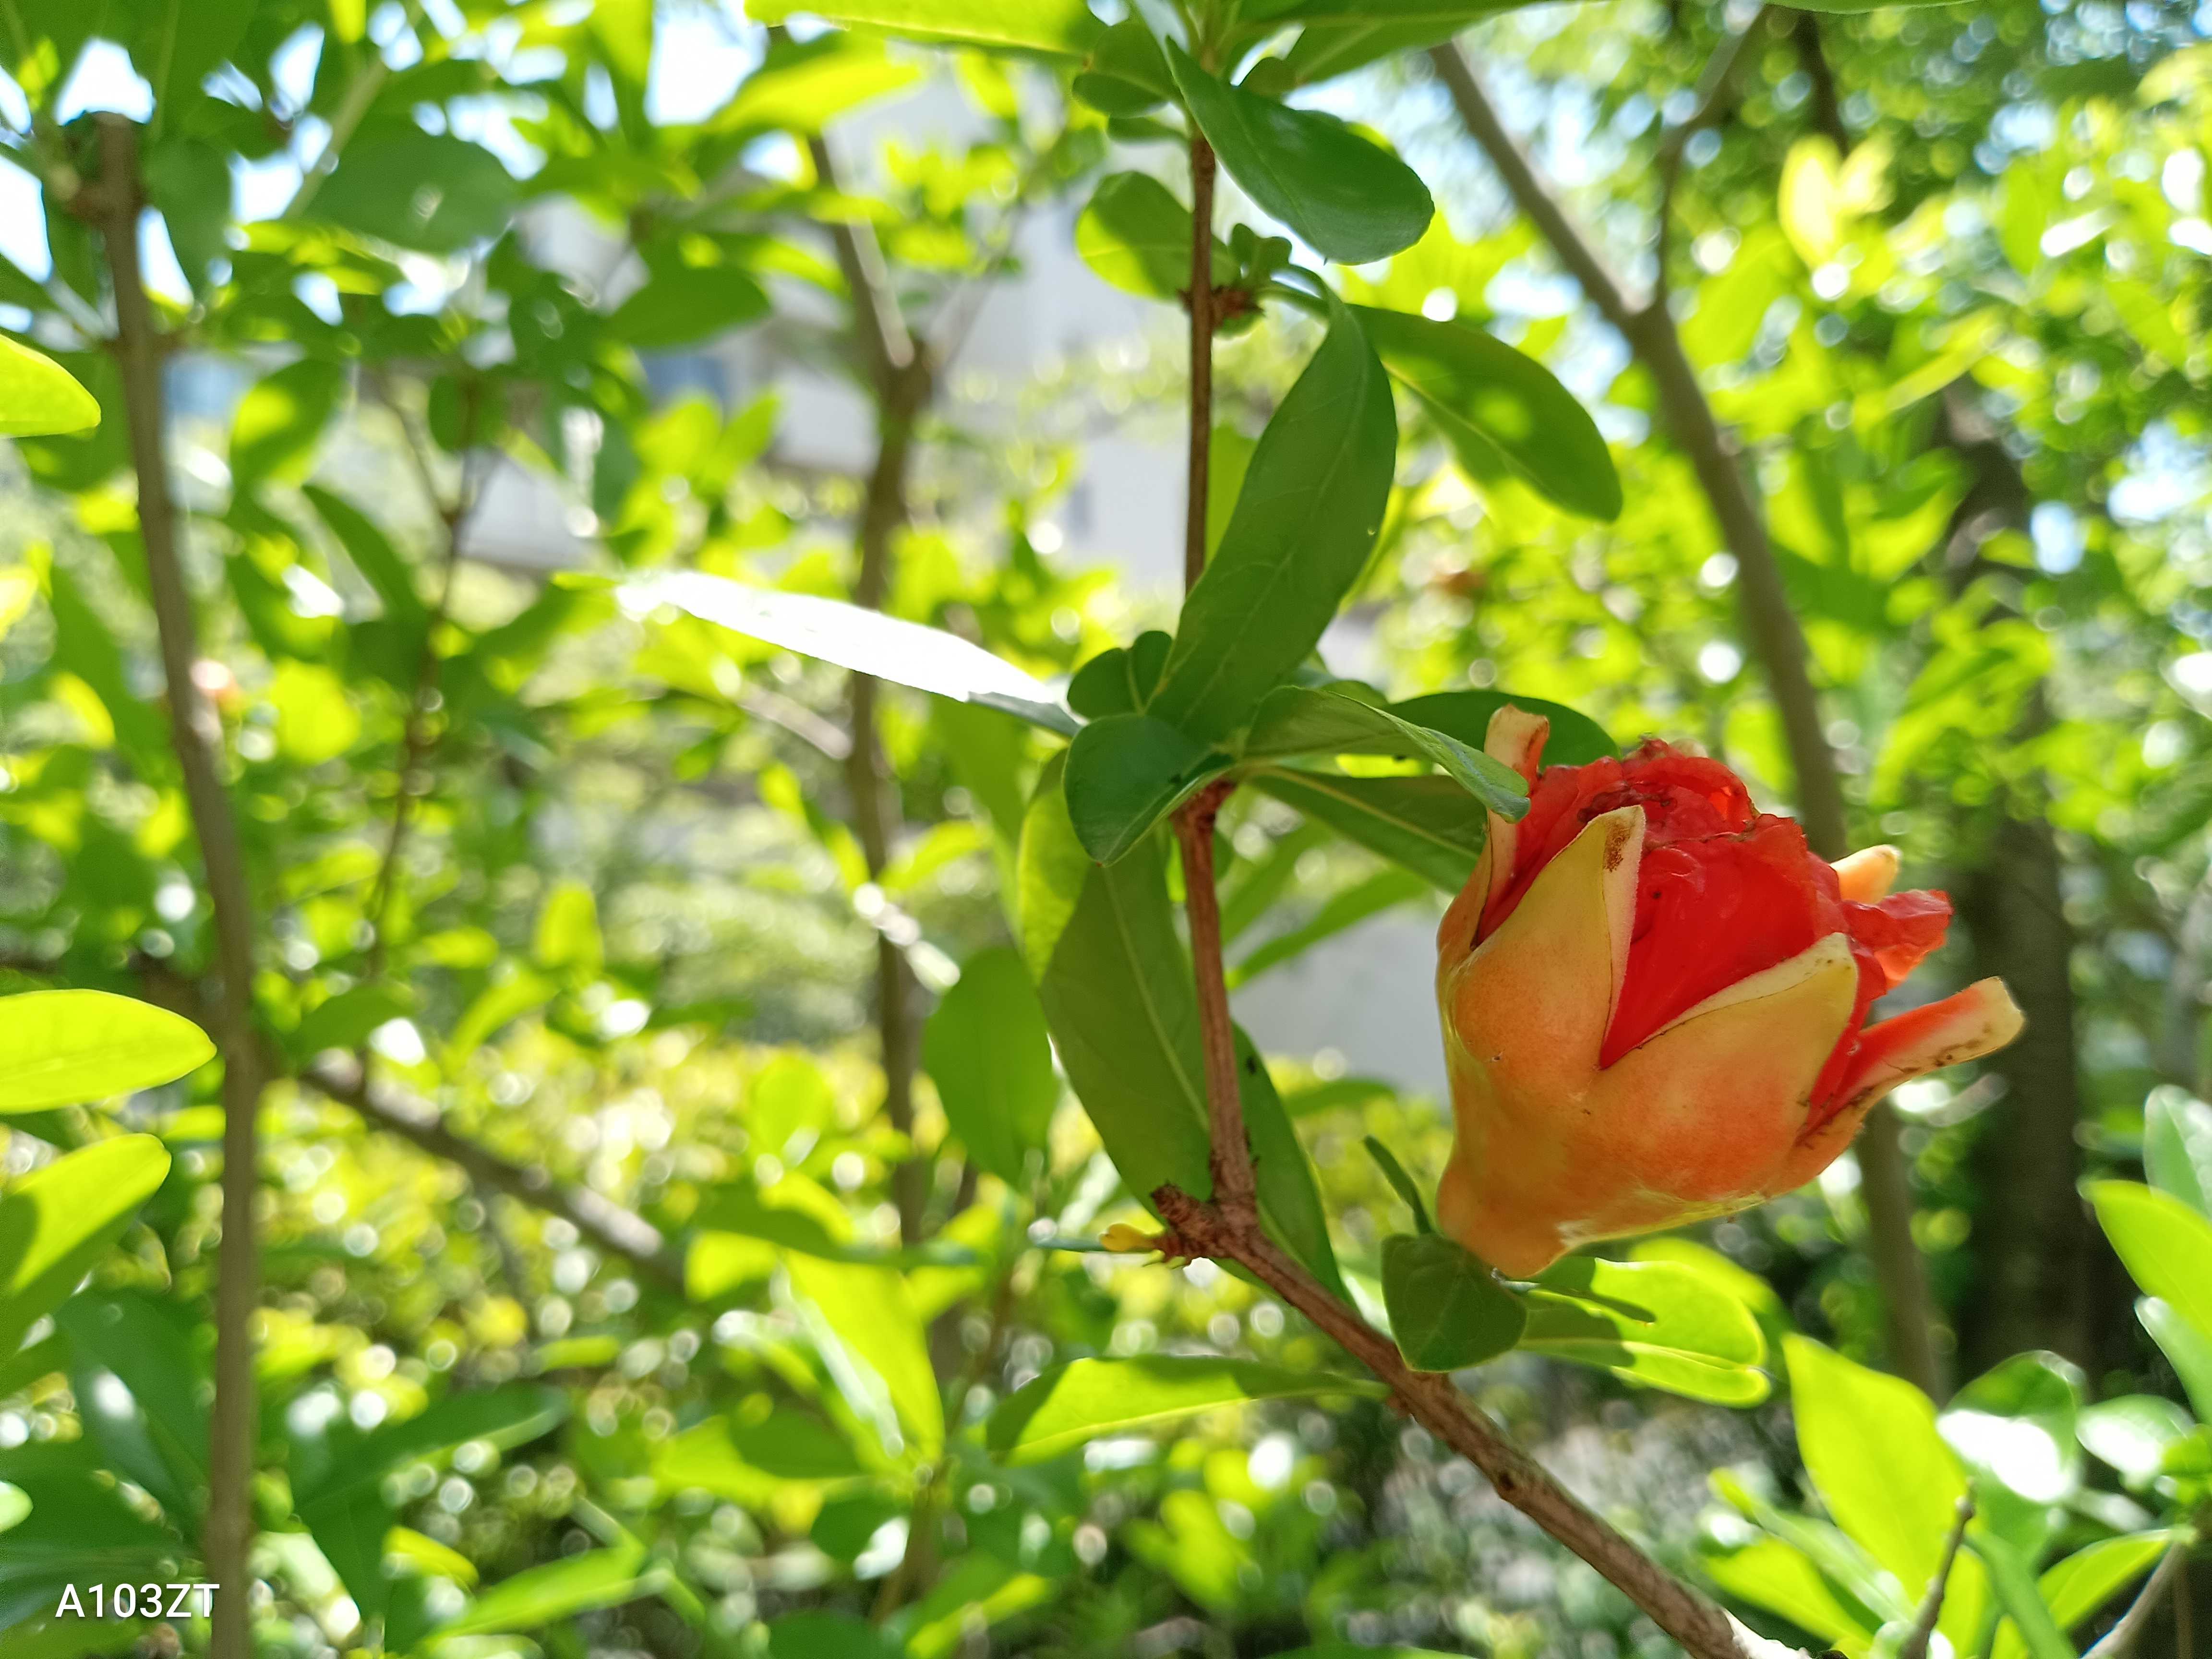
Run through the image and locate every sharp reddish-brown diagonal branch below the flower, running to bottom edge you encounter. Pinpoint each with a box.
[1153,1186,1791,1659]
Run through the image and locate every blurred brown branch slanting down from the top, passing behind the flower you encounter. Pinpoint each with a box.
[1429,44,1942,1398]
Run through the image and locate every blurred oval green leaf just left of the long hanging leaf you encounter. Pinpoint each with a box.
[923,945,1059,1192]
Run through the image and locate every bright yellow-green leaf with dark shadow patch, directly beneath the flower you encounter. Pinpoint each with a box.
[1520,1256,1772,1405]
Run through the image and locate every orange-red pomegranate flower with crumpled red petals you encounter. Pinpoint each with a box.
[1436,708,2020,1276]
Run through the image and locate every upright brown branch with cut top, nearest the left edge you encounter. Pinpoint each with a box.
[71,115,263,1659]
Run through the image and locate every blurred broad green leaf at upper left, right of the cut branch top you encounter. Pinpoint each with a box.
[312,126,520,254]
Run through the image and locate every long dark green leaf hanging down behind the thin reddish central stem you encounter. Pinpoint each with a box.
[1020,761,1343,1289]
